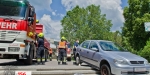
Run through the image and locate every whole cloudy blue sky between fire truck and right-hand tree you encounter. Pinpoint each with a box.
[29,0,128,39]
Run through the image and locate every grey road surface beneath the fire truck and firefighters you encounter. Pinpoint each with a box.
[0,59,99,75]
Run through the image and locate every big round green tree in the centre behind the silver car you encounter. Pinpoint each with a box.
[60,5,112,42]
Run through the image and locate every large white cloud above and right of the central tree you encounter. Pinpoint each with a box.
[62,0,124,31]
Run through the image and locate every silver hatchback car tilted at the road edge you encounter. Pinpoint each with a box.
[76,40,150,75]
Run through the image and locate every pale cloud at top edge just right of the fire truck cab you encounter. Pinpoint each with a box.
[29,0,52,11]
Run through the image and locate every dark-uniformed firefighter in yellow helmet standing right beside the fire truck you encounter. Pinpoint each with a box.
[37,33,45,65]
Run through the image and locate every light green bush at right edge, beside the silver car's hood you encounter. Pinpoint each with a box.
[138,40,150,62]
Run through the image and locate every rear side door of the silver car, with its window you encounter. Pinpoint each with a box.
[79,41,90,61]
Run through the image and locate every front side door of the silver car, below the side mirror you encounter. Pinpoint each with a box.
[87,41,99,65]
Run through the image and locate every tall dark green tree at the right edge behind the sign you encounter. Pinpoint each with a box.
[122,0,150,51]
